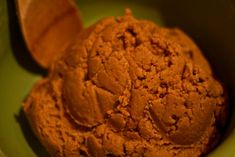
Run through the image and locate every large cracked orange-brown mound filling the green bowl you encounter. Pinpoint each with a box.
[24,13,226,157]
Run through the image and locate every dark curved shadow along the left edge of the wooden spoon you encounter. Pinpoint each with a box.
[7,0,47,75]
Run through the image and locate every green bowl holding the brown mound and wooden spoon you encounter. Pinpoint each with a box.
[0,0,235,157]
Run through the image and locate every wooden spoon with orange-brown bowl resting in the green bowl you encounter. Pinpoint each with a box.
[16,0,82,68]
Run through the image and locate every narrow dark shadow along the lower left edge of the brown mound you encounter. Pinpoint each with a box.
[15,108,50,157]
